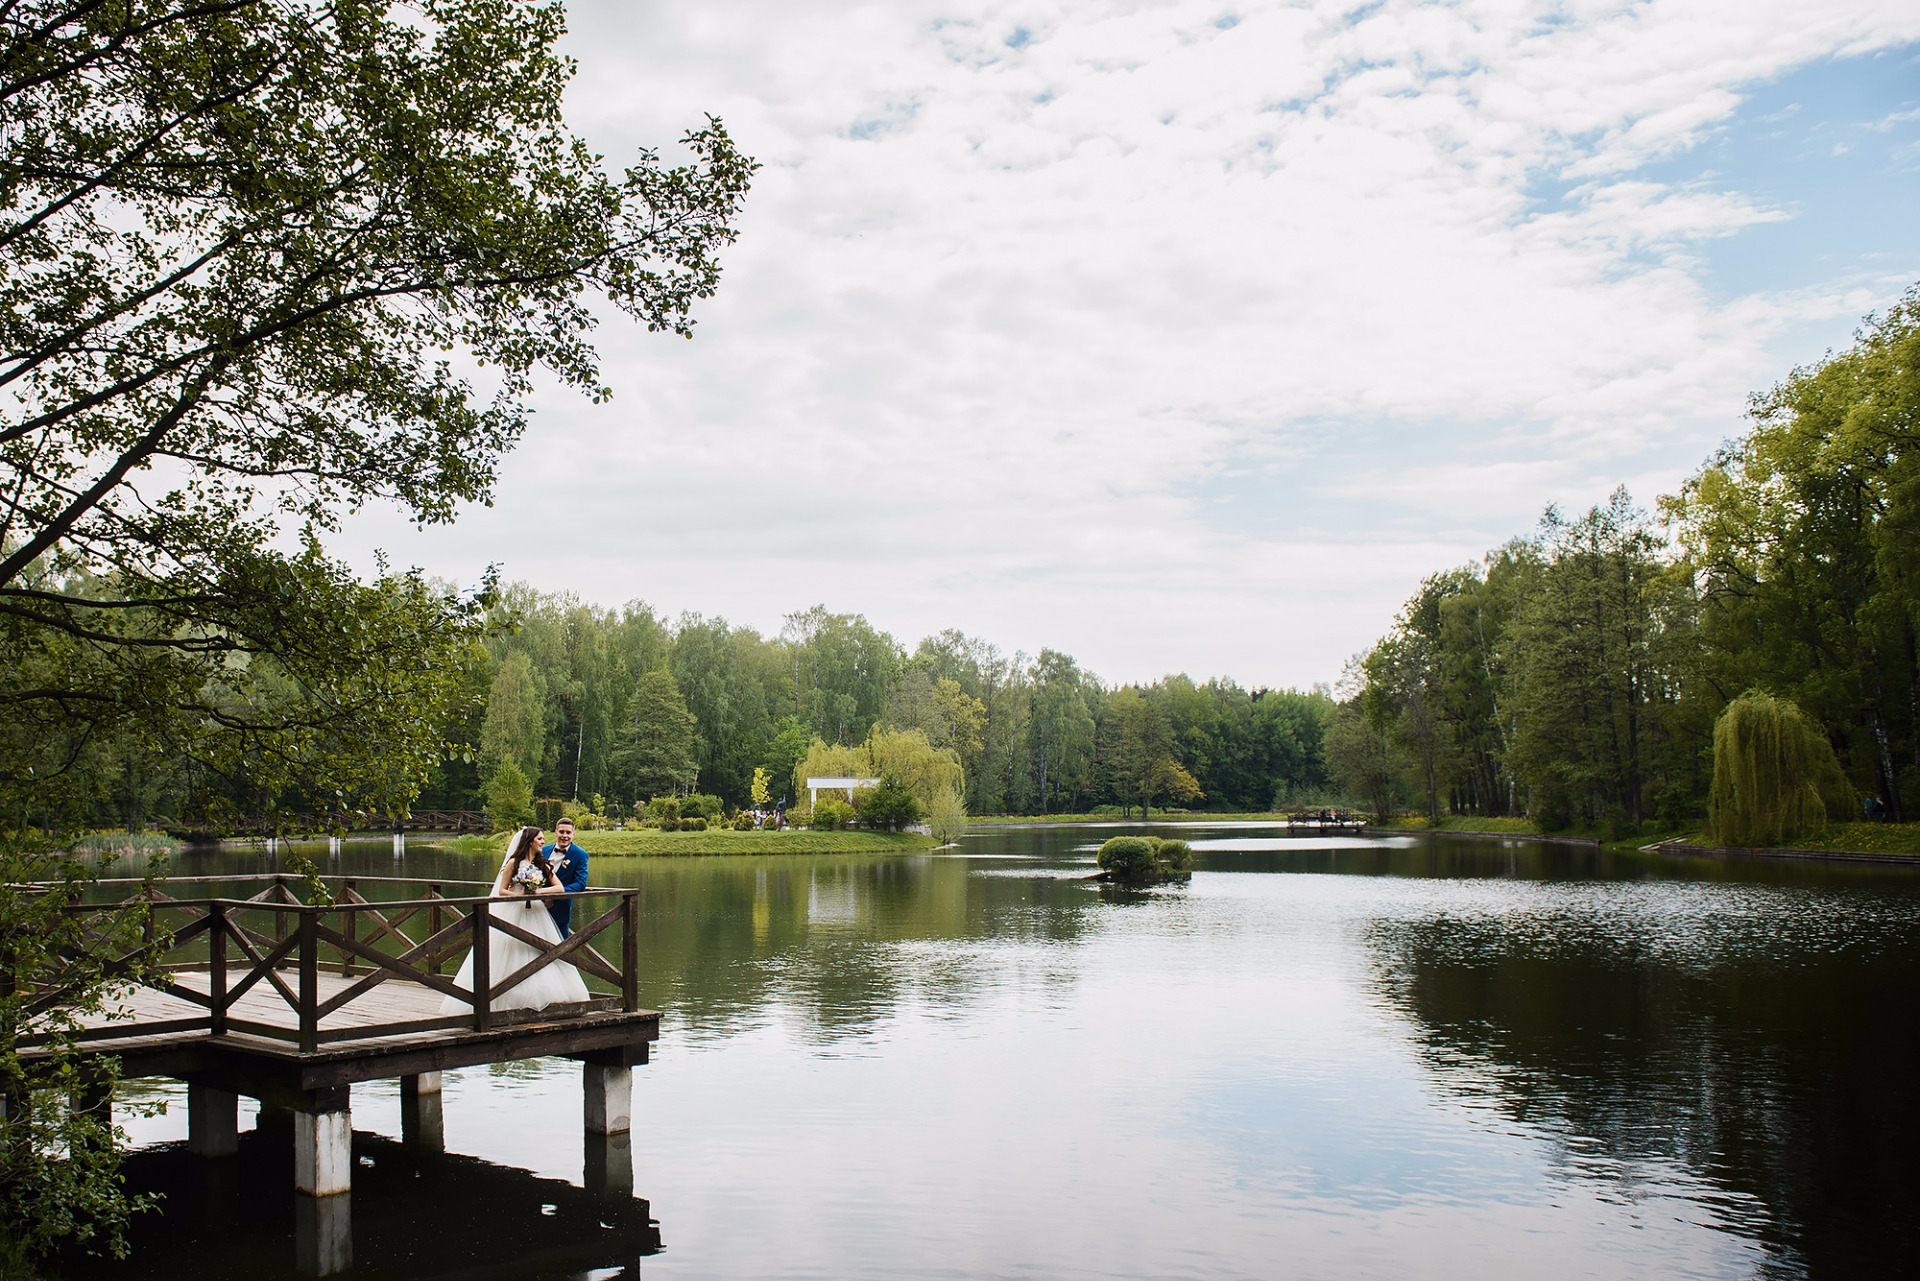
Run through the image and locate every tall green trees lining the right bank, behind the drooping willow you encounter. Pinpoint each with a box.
[1327,288,1920,832]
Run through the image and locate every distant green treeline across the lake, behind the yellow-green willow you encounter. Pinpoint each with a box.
[419,584,1332,814]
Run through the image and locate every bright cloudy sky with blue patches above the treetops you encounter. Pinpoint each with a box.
[336,0,1920,688]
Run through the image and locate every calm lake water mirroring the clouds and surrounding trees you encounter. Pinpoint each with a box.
[83,824,1920,1277]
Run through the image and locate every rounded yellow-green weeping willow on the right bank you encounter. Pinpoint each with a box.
[1707,689,1853,845]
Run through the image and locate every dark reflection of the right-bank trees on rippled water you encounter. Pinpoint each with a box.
[1373,908,1920,1277]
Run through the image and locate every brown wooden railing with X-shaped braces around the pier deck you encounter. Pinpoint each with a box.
[27,876,641,1052]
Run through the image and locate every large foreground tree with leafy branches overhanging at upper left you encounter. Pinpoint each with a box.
[0,0,753,833]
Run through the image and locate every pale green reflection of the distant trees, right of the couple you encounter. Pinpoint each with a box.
[603,857,1089,1039]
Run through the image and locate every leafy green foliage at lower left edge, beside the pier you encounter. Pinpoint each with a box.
[0,835,161,1256]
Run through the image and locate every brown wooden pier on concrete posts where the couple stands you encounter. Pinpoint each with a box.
[25,876,660,1275]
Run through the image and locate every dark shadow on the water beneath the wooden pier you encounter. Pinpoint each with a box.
[60,1129,660,1281]
